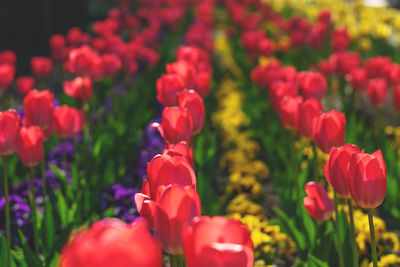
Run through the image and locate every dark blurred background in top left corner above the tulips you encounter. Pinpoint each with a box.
[0,0,89,74]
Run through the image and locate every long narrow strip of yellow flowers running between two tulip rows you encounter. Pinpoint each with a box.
[212,30,295,266]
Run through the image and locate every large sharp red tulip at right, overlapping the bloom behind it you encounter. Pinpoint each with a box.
[348,150,386,209]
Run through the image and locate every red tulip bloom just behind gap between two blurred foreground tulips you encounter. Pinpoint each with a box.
[155,185,201,255]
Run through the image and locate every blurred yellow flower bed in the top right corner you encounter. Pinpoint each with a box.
[263,0,400,46]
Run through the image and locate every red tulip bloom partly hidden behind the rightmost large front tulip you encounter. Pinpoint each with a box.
[325,144,360,198]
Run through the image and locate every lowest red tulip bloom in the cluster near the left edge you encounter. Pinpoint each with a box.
[17,126,44,167]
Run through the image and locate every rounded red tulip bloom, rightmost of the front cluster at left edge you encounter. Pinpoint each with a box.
[53,106,85,138]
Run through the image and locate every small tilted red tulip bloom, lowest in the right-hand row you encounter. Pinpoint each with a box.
[303,182,335,222]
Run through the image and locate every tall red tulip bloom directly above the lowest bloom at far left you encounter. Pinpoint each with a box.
[24,90,54,131]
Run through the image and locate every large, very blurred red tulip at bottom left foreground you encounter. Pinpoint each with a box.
[58,219,162,267]
